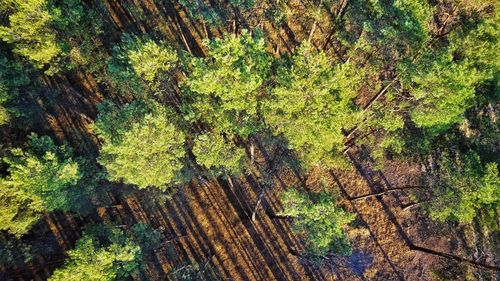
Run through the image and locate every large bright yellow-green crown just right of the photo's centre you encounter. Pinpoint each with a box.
[263,43,362,167]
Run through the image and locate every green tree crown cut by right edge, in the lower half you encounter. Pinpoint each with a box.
[429,152,500,223]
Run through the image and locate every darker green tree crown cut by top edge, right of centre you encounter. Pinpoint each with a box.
[339,0,434,62]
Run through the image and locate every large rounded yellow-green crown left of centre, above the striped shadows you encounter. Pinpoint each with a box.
[94,99,186,190]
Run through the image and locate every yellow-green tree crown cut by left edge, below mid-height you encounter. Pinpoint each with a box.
[0,135,81,236]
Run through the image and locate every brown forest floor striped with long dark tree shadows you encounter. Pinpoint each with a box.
[0,1,500,280]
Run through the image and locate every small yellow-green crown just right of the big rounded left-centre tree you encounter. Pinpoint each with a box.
[193,132,246,175]
